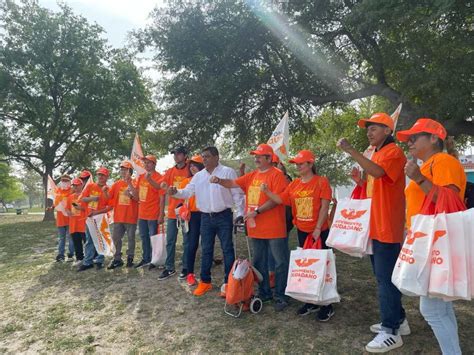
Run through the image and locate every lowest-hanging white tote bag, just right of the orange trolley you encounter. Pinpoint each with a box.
[285,249,329,303]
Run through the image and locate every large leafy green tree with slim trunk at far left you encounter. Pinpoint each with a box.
[0,0,154,219]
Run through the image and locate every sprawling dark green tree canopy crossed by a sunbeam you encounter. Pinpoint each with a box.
[136,0,474,151]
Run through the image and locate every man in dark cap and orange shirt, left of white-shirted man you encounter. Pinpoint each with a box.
[158,147,191,281]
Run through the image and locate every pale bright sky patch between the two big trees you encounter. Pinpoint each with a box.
[39,0,174,172]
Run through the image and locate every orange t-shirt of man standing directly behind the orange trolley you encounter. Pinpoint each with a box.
[235,167,288,239]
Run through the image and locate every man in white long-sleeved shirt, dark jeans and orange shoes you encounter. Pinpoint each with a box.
[168,147,245,296]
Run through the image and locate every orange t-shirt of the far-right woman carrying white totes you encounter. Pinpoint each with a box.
[405,153,466,227]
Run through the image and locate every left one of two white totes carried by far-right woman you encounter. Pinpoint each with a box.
[392,215,434,296]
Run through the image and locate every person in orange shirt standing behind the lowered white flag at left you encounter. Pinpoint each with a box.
[78,167,110,271]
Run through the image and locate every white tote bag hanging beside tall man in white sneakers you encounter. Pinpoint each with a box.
[326,199,372,257]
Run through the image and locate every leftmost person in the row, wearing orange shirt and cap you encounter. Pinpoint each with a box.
[51,174,74,262]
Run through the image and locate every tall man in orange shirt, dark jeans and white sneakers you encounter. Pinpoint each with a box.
[338,113,410,353]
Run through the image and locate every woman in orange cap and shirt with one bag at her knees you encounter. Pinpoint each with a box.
[261,150,334,322]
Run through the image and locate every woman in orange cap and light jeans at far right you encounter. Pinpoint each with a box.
[397,118,466,354]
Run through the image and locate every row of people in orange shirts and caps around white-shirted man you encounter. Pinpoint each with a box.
[51,113,466,354]
